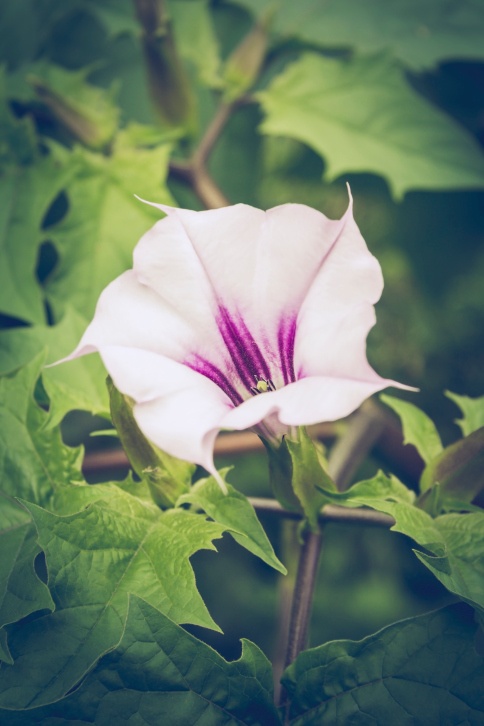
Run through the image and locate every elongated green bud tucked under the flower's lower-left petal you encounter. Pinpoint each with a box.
[107,378,195,509]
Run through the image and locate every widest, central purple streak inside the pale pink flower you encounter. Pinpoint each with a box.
[217,306,271,391]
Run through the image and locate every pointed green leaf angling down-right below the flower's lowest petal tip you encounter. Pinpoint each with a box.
[178,471,287,575]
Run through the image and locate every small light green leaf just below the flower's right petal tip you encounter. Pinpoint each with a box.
[380,395,442,464]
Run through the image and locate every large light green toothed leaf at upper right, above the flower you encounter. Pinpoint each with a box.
[258,53,484,198]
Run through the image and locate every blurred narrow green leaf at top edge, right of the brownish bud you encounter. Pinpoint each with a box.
[168,0,222,88]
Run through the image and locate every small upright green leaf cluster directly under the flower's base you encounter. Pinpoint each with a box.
[264,426,336,531]
